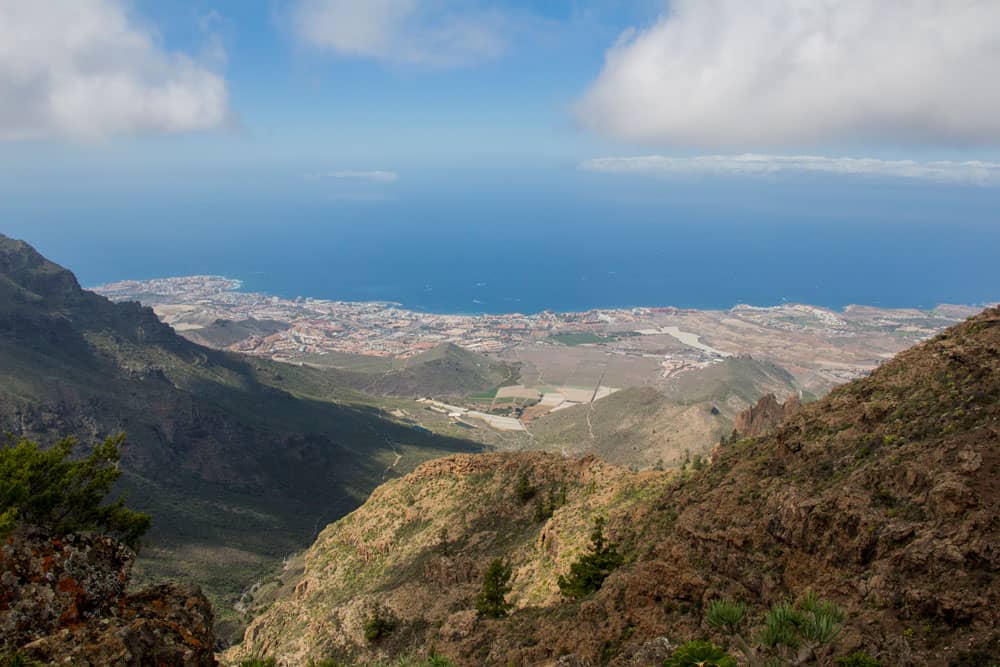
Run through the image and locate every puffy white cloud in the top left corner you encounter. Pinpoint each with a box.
[0,0,228,140]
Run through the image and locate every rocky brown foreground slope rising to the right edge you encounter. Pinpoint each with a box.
[230,308,1000,666]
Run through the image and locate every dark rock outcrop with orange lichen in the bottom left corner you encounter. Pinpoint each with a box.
[0,530,216,667]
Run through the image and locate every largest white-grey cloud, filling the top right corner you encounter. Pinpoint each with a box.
[577,0,1000,150]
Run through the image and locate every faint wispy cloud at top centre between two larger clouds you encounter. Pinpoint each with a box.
[293,0,507,67]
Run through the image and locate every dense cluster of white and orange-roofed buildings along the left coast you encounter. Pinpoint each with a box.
[96,276,647,359]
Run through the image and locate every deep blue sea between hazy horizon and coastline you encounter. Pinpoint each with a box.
[0,167,1000,313]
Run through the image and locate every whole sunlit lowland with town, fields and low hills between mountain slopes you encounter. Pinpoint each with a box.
[95,276,977,469]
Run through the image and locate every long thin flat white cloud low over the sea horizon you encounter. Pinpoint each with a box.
[580,153,1000,185]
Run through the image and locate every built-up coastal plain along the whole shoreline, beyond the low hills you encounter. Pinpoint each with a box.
[94,276,978,400]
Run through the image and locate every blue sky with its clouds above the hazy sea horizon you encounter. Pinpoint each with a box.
[0,0,1000,169]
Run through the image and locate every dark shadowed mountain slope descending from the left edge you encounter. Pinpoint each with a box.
[0,236,473,636]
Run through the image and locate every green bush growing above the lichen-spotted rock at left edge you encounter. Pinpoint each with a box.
[0,434,150,547]
